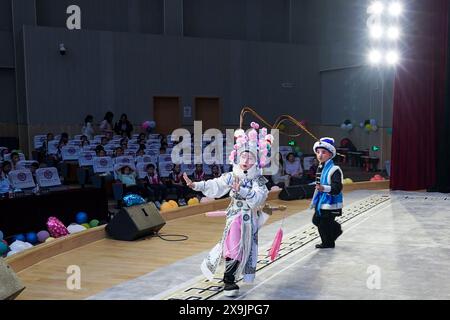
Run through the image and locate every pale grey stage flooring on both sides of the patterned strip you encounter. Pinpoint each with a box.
[90,191,450,300]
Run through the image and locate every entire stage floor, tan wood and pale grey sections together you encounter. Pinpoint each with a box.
[14,190,450,300]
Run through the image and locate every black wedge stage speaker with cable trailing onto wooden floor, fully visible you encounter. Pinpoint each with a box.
[106,202,166,241]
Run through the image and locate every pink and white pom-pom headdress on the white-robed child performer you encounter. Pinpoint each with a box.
[229,122,274,168]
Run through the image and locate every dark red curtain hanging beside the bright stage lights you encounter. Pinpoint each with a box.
[391,0,449,190]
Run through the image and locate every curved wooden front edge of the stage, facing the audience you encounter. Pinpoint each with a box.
[5,180,389,272]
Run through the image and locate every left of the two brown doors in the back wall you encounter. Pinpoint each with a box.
[153,97,181,135]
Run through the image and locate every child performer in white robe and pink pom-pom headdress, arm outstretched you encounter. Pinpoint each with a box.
[184,123,273,296]
